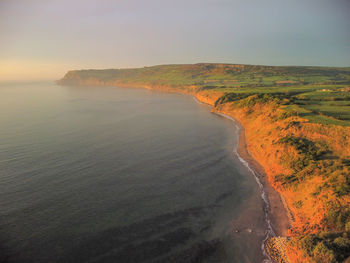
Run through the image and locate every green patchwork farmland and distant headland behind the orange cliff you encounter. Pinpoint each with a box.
[60,63,350,126]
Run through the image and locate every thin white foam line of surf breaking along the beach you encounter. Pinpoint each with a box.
[192,96,276,263]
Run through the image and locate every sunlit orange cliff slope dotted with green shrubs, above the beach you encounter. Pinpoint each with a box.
[217,95,350,262]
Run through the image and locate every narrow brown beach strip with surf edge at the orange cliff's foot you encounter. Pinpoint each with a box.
[192,94,293,263]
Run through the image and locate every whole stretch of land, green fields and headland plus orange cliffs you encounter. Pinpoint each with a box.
[59,64,350,263]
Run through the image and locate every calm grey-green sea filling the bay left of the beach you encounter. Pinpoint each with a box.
[0,83,266,263]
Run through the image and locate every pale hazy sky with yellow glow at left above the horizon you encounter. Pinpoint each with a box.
[0,0,350,81]
